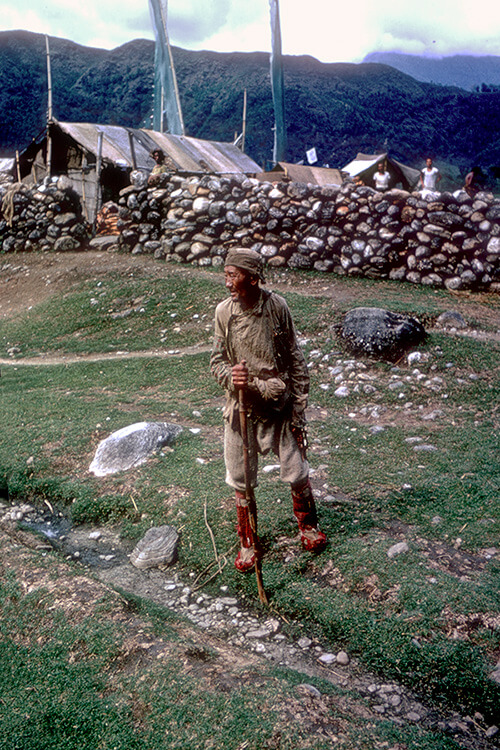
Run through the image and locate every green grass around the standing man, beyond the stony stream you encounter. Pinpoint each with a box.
[0,264,500,736]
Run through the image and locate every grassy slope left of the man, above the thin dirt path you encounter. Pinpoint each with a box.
[0,277,223,356]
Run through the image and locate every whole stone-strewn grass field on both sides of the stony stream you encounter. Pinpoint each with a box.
[0,256,500,750]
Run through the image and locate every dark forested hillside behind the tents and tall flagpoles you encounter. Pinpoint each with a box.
[0,31,500,182]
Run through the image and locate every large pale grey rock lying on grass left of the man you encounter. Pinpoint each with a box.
[89,422,182,477]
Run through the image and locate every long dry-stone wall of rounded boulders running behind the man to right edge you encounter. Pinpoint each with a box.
[119,176,500,289]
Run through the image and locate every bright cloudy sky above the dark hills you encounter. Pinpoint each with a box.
[0,0,500,62]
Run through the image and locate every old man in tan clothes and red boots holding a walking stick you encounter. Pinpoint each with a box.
[210,248,326,571]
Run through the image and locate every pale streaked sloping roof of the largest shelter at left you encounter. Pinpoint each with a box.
[56,122,260,174]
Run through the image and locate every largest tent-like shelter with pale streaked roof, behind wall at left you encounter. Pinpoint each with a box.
[19,120,260,221]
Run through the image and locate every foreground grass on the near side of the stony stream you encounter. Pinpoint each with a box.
[0,568,468,750]
